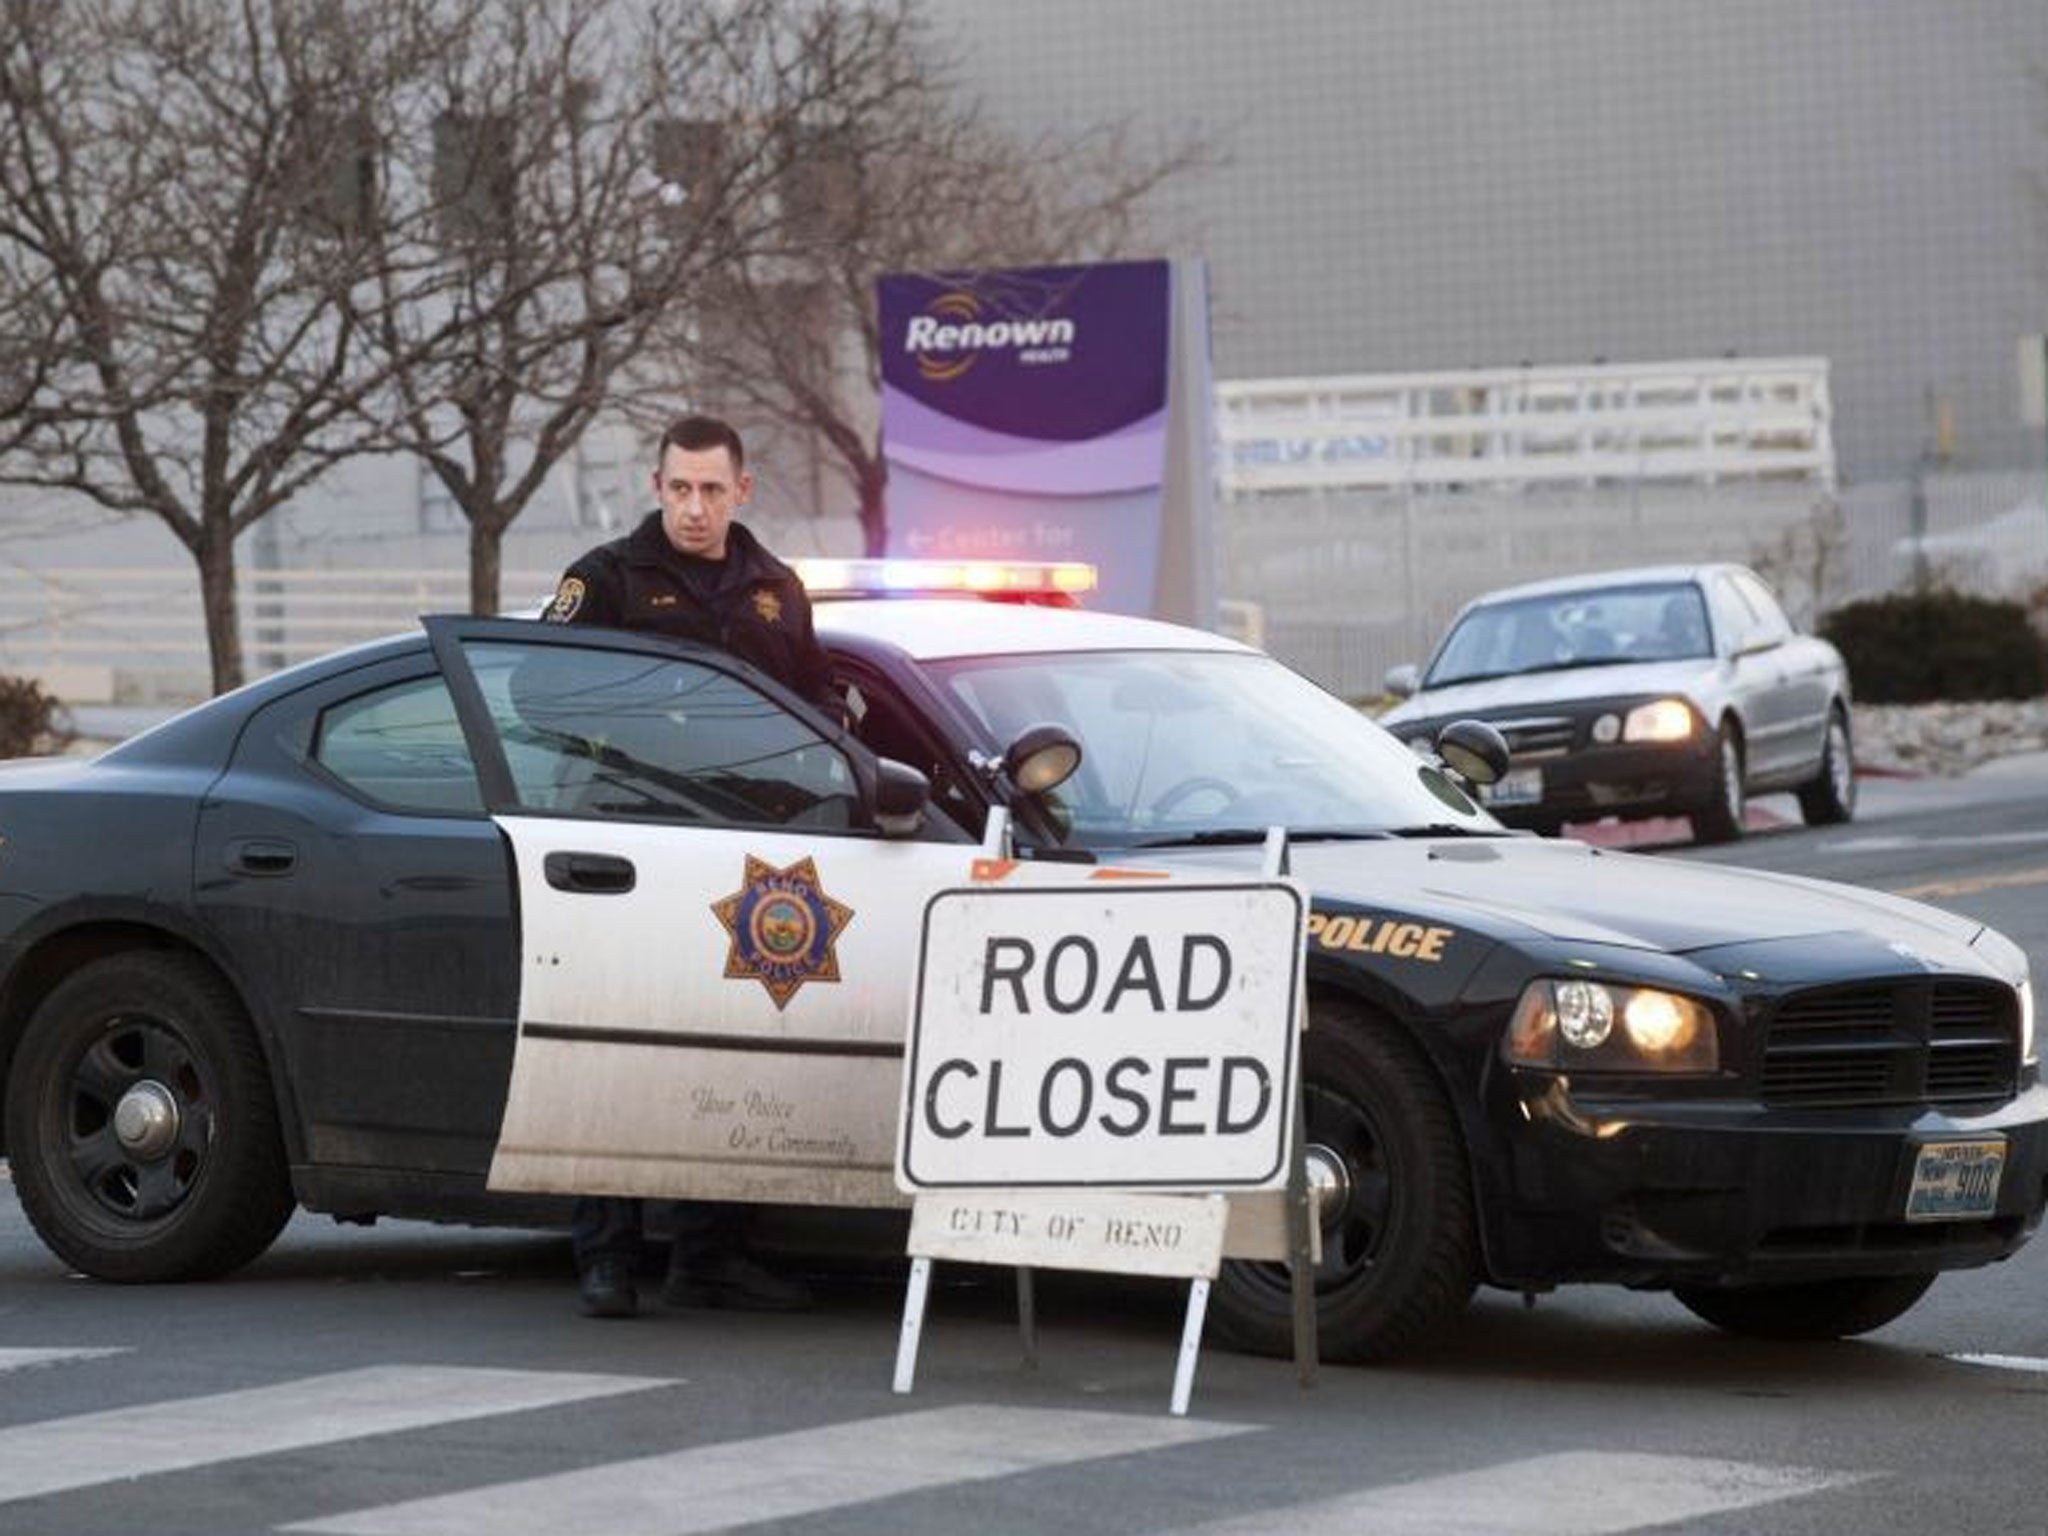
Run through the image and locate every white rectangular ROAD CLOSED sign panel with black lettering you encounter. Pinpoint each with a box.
[897,881,1307,1194]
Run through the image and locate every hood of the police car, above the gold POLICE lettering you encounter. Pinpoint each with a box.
[1176,838,1982,954]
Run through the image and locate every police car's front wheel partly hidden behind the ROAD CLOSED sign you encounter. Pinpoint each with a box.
[1210,1001,1479,1362]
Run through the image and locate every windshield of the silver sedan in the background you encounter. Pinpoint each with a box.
[1423,582,1714,688]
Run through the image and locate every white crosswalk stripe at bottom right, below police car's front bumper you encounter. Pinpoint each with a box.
[1184,1450,1864,1536]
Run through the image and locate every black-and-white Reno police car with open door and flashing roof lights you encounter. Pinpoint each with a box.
[0,567,2048,1360]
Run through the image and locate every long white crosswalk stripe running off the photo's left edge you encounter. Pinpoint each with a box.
[0,1366,674,1503]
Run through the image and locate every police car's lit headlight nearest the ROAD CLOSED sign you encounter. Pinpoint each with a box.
[1505,977,1720,1071]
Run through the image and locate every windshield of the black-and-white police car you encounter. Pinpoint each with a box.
[928,651,1501,848]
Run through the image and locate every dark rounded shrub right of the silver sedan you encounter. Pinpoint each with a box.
[1821,588,2048,705]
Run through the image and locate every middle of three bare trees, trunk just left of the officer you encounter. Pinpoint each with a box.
[362,0,776,612]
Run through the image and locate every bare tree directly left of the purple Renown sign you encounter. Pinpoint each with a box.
[647,0,1214,553]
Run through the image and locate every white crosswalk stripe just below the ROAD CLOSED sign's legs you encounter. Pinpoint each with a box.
[287,1407,1253,1536]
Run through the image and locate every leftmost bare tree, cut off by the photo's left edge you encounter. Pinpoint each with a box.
[0,0,465,688]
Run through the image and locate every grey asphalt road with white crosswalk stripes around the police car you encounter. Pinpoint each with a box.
[0,760,2048,1536]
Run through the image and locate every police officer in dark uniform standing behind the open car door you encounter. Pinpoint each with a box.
[543,416,840,1317]
